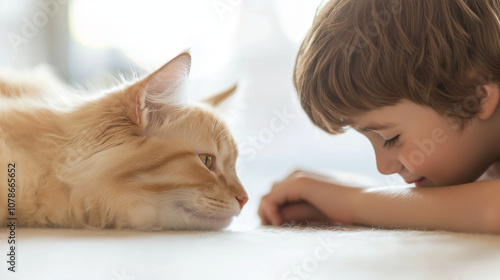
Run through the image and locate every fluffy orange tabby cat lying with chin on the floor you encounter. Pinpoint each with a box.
[0,53,248,230]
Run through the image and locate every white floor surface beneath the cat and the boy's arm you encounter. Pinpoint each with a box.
[0,222,500,280]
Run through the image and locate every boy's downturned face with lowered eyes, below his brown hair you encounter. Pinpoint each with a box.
[352,100,496,187]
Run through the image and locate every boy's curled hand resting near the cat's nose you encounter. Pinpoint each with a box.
[259,171,353,225]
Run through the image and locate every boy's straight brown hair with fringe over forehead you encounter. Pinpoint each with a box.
[294,0,500,134]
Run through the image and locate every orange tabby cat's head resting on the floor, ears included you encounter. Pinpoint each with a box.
[59,53,248,230]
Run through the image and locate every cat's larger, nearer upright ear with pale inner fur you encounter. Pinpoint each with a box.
[129,52,191,126]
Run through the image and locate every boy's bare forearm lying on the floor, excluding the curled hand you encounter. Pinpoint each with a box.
[302,180,500,233]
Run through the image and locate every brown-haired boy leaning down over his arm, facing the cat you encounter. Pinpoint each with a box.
[259,0,500,233]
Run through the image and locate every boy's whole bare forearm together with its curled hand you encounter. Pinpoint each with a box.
[259,171,500,234]
